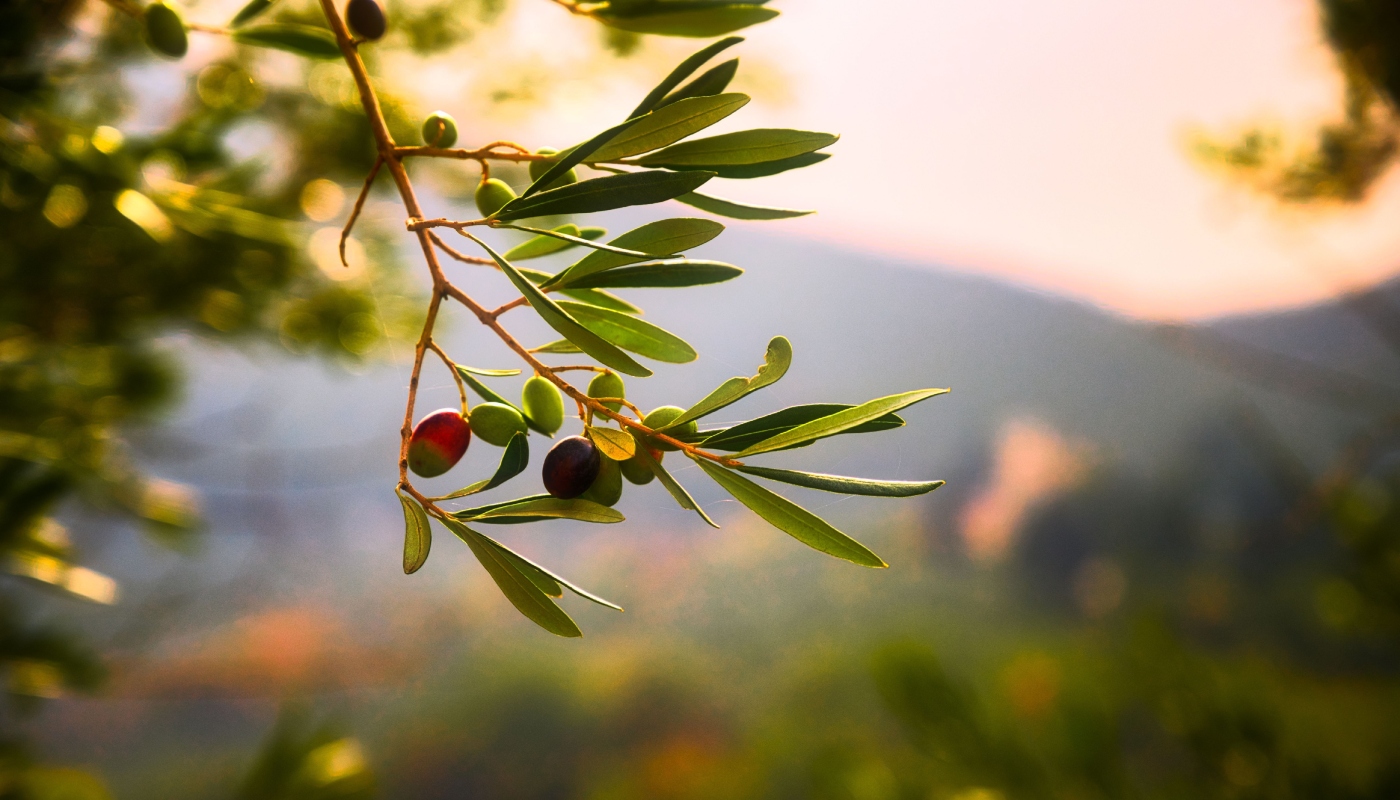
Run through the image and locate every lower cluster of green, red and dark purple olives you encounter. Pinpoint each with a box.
[409,371,697,506]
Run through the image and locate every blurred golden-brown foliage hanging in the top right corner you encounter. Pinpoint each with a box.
[1193,0,1400,203]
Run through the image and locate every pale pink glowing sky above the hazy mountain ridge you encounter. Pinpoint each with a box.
[397,0,1400,318]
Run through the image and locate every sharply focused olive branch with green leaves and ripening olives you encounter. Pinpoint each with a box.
[117,0,948,636]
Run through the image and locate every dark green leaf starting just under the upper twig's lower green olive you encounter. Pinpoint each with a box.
[494,170,714,220]
